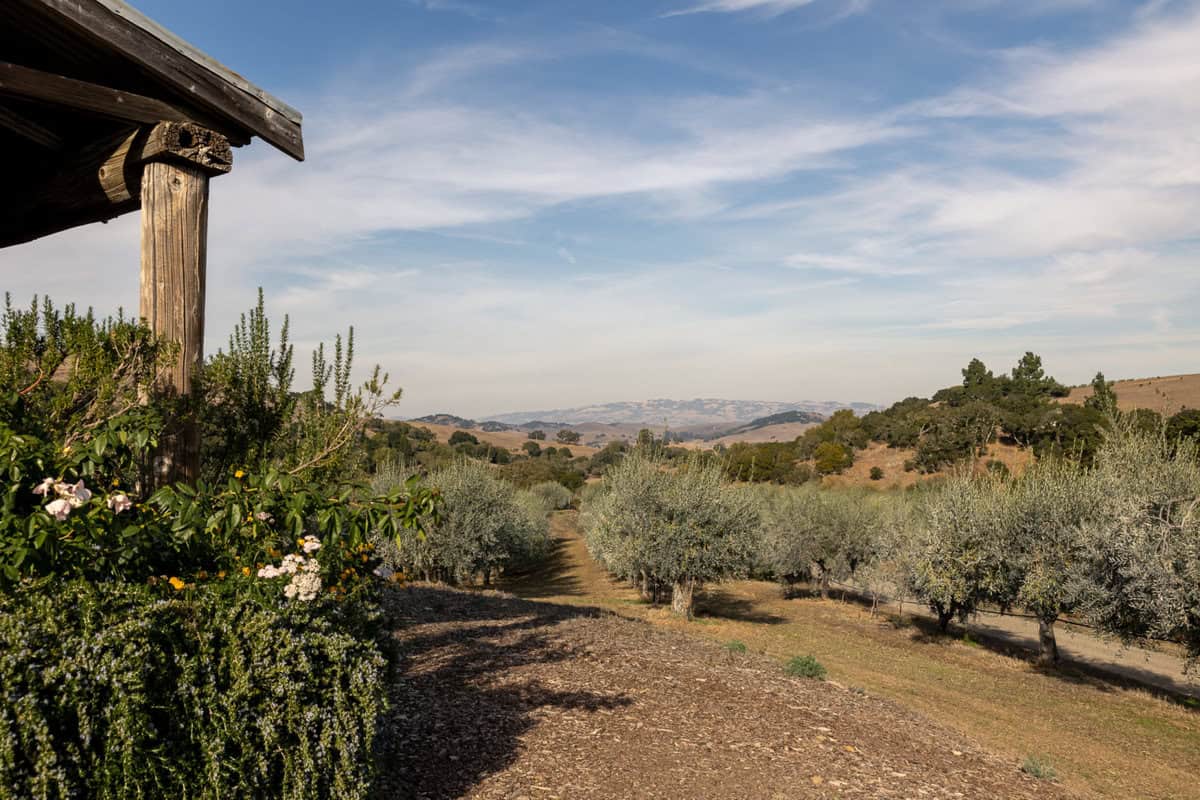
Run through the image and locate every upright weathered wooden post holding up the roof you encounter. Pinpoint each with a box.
[140,124,228,486]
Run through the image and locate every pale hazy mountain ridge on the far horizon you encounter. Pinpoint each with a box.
[487,398,880,429]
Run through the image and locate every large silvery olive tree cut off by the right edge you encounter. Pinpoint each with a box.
[1084,421,1200,667]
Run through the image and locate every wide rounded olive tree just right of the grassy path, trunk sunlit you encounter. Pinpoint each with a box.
[586,449,760,619]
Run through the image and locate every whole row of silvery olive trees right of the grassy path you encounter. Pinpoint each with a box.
[583,420,1200,662]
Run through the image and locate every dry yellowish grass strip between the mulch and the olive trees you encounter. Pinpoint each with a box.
[506,512,1200,800]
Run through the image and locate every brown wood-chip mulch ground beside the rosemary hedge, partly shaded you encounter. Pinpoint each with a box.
[378,584,1068,800]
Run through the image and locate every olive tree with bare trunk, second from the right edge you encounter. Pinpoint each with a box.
[997,459,1099,664]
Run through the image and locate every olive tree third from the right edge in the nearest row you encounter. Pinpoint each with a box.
[910,469,1012,631]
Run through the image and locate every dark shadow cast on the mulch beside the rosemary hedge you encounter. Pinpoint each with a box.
[374,585,631,800]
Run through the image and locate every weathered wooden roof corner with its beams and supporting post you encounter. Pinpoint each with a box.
[0,0,304,480]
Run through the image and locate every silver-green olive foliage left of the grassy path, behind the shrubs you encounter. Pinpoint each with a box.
[377,459,548,583]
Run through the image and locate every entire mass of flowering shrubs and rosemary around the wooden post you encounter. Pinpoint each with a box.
[0,301,439,800]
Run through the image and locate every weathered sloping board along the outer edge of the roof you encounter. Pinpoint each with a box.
[22,0,304,161]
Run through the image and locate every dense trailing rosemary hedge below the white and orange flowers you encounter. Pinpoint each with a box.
[0,581,385,800]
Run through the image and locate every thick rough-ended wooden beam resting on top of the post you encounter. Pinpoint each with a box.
[0,122,233,247]
